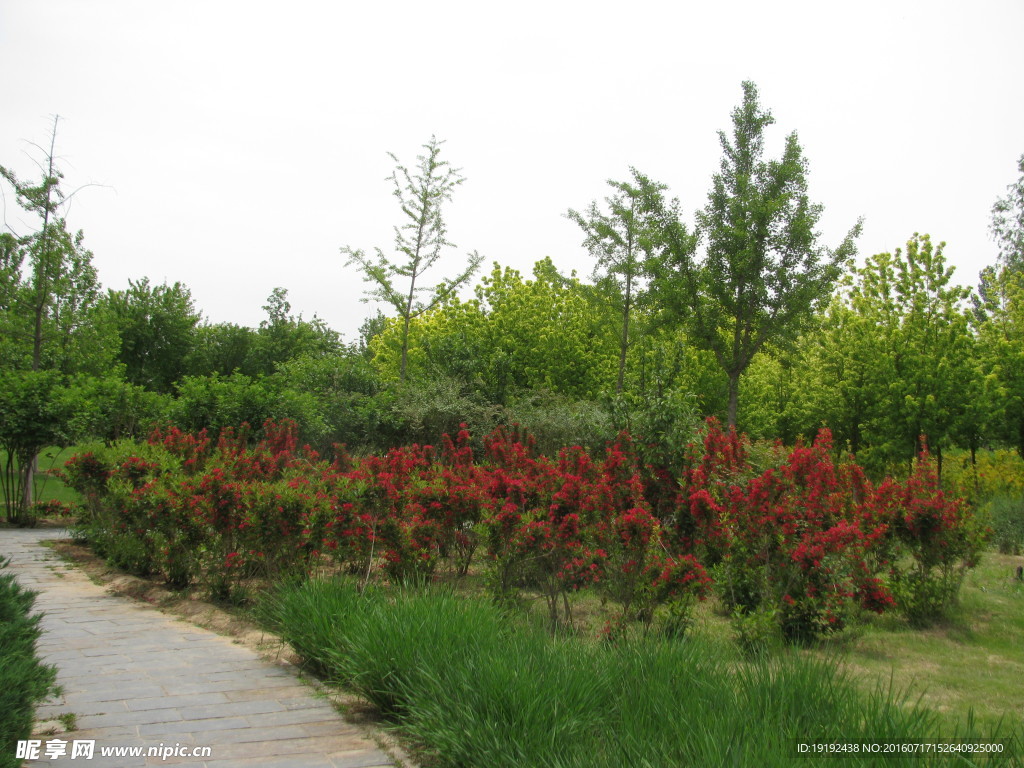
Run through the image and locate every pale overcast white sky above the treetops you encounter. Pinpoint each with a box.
[0,0,1024,341]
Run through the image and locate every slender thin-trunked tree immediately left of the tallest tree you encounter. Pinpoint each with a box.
[565,168,668,394]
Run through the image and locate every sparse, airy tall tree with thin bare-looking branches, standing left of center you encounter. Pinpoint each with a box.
[341,136,483,381]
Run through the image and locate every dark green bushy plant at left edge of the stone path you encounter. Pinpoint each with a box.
[0,557,56,768]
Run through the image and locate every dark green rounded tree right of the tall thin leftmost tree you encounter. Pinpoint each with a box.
[106,278,200,392]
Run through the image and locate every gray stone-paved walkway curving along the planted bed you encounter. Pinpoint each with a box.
[0,530,393,768]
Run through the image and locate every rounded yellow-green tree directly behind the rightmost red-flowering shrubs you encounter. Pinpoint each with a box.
[819,234,979,471]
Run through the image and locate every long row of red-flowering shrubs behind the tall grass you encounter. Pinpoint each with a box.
[66,421,981,639]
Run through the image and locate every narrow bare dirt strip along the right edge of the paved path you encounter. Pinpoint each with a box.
[49,539,416,768]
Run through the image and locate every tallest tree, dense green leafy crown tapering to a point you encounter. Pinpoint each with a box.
[662,82,860,425]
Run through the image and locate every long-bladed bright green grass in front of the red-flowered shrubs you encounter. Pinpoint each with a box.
[261,581,1020,768]
